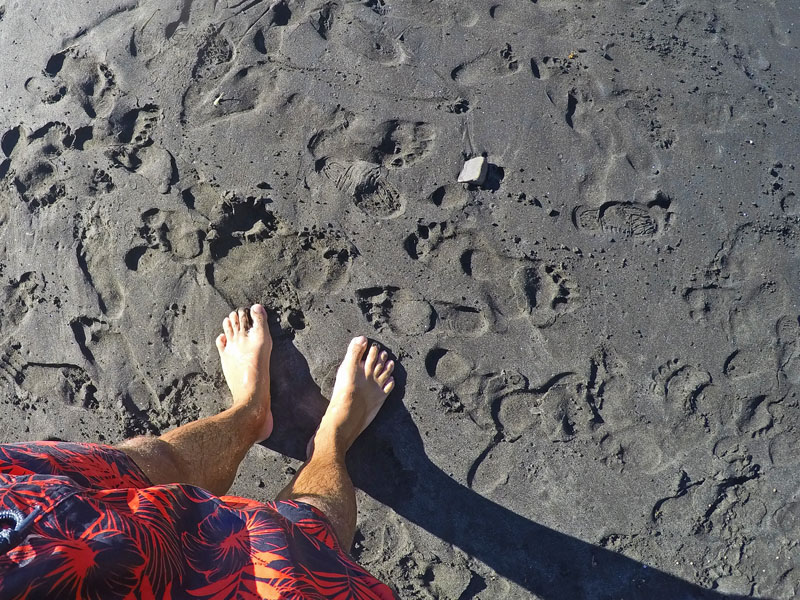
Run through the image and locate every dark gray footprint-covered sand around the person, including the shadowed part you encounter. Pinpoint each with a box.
[0,0,800,600]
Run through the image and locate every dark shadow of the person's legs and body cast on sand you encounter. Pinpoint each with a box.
[260,338,764,600]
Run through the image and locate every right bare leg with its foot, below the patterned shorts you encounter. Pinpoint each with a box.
[277,336,394,551]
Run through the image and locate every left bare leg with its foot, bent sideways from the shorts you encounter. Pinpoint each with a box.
[117,304,272,495]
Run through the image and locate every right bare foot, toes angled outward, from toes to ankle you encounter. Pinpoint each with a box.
[308,336,394,455]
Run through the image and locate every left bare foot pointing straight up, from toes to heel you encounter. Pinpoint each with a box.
[217,304,272,442]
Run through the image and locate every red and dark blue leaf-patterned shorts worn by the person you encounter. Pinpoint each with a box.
[0,442,395,600]
